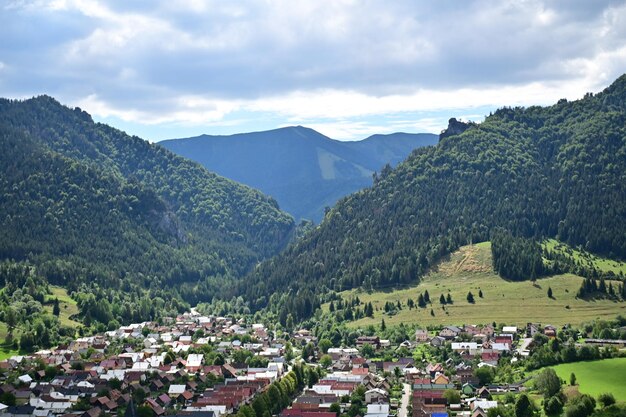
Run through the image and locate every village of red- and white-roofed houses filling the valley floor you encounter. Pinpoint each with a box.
[0,310,616,417]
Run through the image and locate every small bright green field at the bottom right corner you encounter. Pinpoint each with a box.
[553,358,626,401]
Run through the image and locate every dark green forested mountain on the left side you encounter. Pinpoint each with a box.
[0,96,295,324]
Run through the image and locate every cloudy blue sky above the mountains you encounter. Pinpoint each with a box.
[0,0,626,141]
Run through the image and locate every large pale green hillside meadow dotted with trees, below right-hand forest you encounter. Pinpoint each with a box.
[334,242,626,327]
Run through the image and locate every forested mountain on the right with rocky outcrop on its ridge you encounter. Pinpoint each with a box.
[233,76,626,323]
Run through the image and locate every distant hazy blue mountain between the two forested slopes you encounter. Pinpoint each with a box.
[159,126,438,222]
